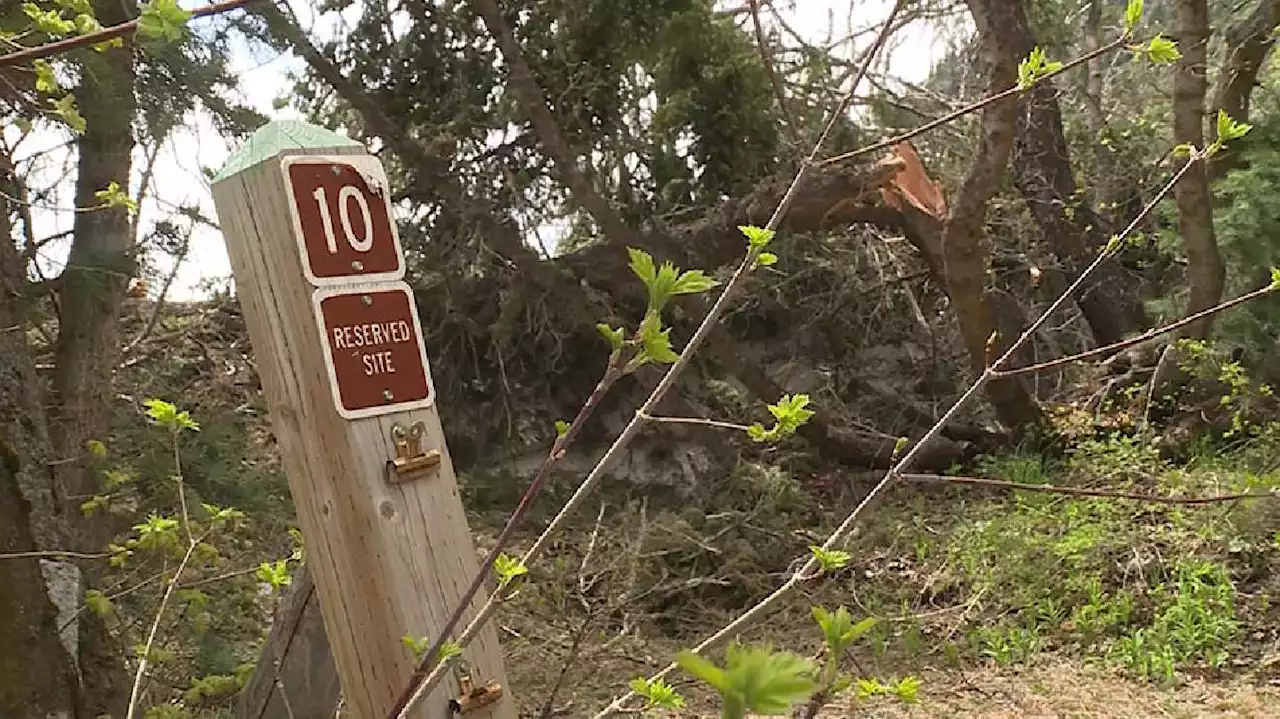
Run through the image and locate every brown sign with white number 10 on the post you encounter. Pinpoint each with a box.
[282,155,404,287]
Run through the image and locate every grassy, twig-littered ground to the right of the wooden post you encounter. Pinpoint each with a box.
[494,424,1280,716]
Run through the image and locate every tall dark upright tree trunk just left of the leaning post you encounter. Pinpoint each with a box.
[0,0,137,716]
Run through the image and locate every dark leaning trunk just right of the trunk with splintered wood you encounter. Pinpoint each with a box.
[970,0,1146,344]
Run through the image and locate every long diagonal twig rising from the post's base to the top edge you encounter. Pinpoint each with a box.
[399,0,906,719]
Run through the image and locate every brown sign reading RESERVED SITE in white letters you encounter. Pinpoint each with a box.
[314,283,435,420]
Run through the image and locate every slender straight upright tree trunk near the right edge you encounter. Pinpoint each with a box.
[1174,0,1226,339]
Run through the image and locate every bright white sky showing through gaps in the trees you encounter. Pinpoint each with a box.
[5,0,941,302]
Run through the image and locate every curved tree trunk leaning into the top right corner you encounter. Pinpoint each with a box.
[1208,0,1280,182]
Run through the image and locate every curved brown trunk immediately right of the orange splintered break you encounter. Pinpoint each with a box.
[942,0,1043,431]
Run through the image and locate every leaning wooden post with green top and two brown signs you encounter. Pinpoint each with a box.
[212,122,516,719]
